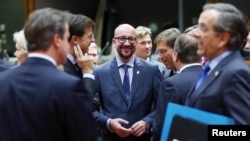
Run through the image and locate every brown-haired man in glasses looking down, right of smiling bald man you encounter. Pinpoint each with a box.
[154,28,181,78]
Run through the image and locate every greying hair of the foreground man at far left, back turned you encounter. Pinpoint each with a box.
[24,8,68,51]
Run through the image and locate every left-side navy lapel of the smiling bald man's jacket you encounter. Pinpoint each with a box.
[110,58,128,106]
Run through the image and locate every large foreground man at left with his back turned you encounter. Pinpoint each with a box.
[0,8,97,141]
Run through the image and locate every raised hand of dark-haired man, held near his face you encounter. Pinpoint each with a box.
[74,45,94,74]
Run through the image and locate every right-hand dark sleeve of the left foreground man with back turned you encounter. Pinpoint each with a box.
[65,80,97,141]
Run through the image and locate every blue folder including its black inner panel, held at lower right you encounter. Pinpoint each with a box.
[160,102,235,141]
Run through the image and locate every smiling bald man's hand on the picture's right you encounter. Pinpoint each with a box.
[131,120,148,137]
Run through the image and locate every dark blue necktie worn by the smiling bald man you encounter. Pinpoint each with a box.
[122,64,130,102]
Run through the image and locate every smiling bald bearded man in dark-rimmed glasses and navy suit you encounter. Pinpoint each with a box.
[94,24,162,141]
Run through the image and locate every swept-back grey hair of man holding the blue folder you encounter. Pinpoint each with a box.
[203,3,248,50]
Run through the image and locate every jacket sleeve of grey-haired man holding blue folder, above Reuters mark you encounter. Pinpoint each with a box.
[224,70,250,124]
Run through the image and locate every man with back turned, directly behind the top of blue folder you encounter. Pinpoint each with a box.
[152,34,202,141]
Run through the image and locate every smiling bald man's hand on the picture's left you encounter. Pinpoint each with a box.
[109,118,132,137]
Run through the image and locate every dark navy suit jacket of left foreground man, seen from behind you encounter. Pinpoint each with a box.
[0,57,97,141]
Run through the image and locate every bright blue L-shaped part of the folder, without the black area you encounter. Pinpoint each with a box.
[161,102,235,141]
